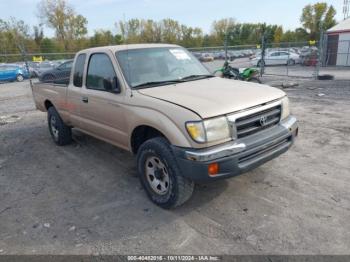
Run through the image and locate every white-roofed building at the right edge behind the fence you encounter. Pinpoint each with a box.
[326,18,350,66]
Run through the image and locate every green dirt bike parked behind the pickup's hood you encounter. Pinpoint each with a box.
[214,62,261,84]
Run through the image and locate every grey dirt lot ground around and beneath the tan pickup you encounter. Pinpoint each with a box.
[0,75,350,254]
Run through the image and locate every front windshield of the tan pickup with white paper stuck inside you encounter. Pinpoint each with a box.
[116,47,212,88]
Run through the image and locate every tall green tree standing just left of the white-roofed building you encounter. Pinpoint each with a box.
[300,2,336,40]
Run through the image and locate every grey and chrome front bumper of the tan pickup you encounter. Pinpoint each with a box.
[173,116,298,182]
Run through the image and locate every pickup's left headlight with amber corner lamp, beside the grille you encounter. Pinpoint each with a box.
[186,117,230,143]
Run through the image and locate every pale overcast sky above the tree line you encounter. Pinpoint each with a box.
[0,0,343,35]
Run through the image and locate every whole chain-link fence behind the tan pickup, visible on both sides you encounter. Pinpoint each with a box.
[0,34,350,83]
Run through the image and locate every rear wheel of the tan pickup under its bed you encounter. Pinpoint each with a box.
[47,106,72,146]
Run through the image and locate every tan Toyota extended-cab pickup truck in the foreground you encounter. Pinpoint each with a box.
[32,44,298,208]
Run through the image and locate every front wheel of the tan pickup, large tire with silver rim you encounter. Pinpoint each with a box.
[137,137,194,209]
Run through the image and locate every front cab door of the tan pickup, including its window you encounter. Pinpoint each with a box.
[81,52,128,148]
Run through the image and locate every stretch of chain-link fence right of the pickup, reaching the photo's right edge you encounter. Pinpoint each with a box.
[190,34,350,80]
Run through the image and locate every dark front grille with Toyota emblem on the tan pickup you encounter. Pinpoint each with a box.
[236,105,281,138]
